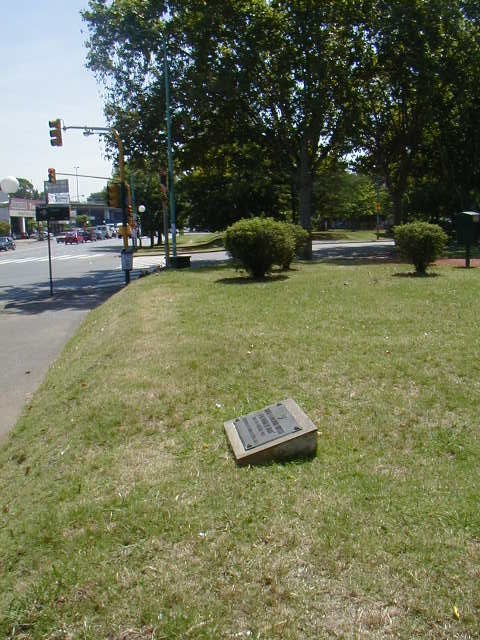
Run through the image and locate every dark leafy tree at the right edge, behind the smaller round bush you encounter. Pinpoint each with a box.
[361,0,480,224]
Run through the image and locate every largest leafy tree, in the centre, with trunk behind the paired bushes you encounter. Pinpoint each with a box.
[83,0,370,255]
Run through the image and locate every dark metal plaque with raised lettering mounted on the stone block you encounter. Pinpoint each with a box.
[233,402,301,451]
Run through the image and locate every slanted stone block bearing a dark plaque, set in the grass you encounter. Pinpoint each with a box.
[224,398,317,465]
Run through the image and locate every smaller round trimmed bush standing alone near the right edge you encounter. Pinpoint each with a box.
[393,222,447,275]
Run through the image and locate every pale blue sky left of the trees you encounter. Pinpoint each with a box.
[0,0,112,200]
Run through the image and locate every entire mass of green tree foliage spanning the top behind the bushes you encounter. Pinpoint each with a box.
[83,0,480,234]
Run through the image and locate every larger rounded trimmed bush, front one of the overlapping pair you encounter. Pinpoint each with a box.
[225,218,295,278]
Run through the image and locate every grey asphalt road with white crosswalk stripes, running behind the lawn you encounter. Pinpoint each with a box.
[0,239,393,440]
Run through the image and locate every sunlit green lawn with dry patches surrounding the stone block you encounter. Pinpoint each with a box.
[0,263,480,640]
